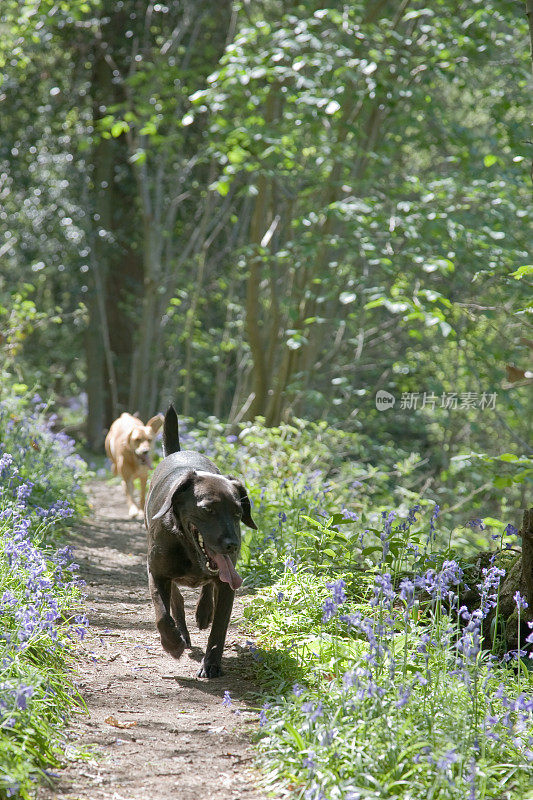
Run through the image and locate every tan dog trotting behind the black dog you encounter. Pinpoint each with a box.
[105,413,163,519]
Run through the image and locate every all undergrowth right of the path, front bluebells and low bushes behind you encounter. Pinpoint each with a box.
[189,425,533,800]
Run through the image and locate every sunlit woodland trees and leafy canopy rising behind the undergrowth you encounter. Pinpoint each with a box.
[0,0,531,516]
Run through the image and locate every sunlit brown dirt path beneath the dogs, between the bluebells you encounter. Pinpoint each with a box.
[38,482,264,800]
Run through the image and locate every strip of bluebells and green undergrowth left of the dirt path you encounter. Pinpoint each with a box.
[0,397,87,800]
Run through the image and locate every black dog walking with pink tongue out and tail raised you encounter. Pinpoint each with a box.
[145,406,256,678]
